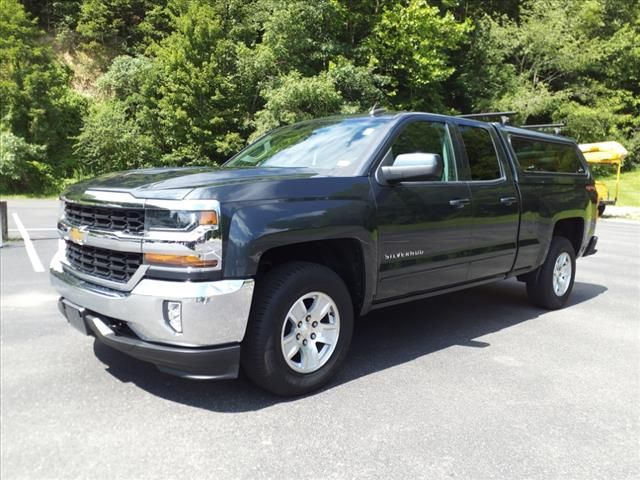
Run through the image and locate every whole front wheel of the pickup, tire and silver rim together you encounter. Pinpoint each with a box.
[242,262,353,396]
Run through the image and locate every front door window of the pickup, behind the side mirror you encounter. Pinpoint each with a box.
[391,120,458,182]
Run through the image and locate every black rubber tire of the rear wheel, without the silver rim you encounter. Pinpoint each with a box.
[527,237,576,310]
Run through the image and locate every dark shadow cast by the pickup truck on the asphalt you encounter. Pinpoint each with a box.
[94,280,607,412]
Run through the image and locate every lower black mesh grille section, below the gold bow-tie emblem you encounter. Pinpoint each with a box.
[66,241,142,283]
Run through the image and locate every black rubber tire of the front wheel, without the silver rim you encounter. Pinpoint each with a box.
[241,262,354,396]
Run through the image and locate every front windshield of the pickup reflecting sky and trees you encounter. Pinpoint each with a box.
[224,117,390,174]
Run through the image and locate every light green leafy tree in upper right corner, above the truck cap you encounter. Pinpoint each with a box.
[484,0,640,168]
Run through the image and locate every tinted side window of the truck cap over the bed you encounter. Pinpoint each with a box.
[510,135,585,174]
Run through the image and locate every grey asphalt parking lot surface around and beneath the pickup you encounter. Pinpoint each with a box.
[0,200,640,479]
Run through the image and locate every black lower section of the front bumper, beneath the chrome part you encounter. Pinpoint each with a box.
[58,298,240,379]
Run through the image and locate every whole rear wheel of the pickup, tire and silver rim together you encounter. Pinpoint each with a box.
[527,237,576,310]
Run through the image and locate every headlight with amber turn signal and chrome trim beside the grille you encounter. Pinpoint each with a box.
[142,200,222,270]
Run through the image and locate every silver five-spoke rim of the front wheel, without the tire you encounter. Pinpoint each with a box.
[280,292,340,374]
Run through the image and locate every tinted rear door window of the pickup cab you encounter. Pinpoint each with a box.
[460,125,502,181]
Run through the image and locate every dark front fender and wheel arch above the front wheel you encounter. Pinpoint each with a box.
[223,199,377,314]
